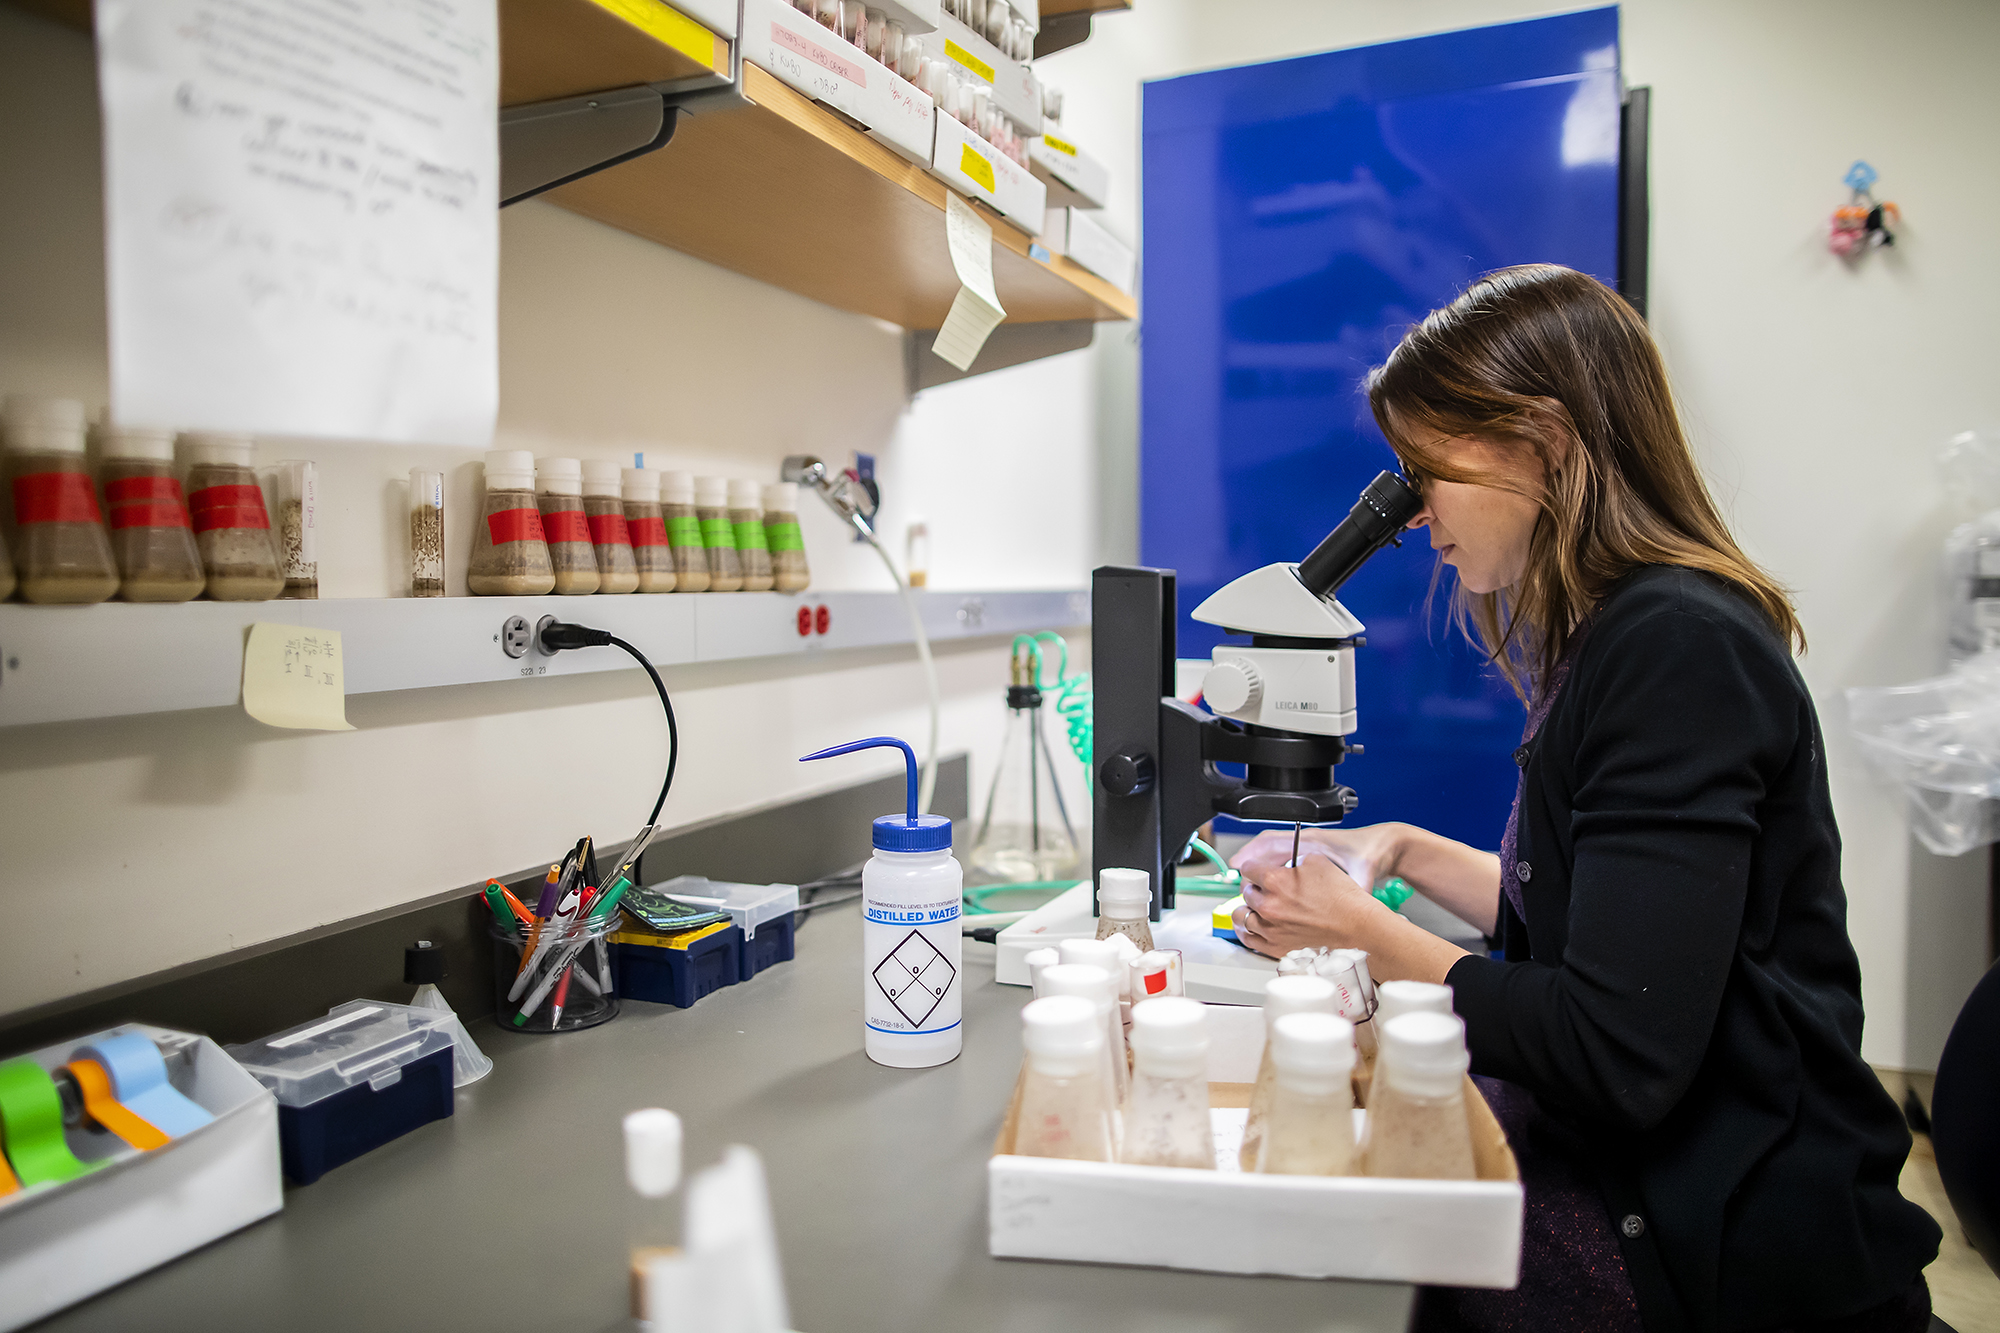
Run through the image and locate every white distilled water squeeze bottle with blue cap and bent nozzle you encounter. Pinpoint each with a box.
[800,737,966,1069]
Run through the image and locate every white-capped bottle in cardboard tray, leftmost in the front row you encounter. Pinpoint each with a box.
[1014,995,1114,1161]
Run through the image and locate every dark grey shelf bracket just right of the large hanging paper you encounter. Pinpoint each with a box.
[500,86,680,208]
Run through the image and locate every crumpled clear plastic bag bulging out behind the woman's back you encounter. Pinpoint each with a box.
[1848,648,2000,857]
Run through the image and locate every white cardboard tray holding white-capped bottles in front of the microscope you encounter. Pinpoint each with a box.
[986,1005,1522,1287]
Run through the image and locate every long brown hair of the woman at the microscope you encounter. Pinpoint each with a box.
[1368,264,1806,699]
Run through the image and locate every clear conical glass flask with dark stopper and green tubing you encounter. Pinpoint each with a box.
[972,652,1076,883]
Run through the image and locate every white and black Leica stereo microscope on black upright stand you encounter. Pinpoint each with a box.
[1090,472,1422,921]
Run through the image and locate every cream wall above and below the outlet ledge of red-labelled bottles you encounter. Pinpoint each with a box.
[0,6,1098,1013]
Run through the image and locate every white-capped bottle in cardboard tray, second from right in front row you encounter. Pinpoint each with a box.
[1256,1013,1354,1175]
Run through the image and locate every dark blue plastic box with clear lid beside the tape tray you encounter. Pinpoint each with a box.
[226,1001,452,1185]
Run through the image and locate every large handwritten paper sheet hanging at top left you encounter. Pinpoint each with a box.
[96,0,500,446]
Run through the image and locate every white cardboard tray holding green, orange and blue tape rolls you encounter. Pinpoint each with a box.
[0,1023,284,1329]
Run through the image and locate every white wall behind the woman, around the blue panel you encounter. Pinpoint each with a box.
[1044,0,2000,1069]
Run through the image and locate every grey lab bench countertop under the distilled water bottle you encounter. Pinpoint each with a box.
[36,905,1412,1333]
